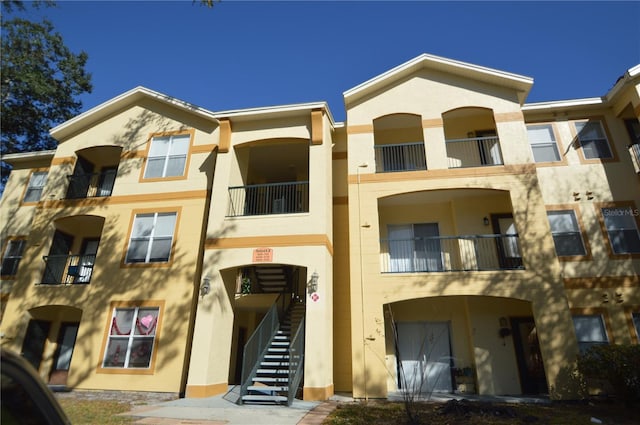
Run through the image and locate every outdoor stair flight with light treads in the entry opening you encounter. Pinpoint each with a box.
[241,302,305,404]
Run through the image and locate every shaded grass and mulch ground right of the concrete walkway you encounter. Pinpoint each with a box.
[323,400,640,425]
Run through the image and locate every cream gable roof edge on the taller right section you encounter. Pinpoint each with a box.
[343,53,533,105]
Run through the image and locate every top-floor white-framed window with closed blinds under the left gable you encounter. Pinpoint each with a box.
[144,134,191,179]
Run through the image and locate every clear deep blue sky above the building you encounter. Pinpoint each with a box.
[21,0,640,121]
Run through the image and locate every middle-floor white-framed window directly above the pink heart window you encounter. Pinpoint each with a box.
[125,212,177,263]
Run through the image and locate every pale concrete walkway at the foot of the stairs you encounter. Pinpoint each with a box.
[123,395,338,425]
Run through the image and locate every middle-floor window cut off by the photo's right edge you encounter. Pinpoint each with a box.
[602,207,640,254]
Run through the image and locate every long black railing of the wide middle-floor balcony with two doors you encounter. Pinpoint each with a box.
[380,235,523,273]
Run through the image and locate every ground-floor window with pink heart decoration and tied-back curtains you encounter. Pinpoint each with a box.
[102,307,160,369]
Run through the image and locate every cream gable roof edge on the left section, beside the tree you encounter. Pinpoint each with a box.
[49,86,217,141]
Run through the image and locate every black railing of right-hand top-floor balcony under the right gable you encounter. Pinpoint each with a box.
[446,136,503,168]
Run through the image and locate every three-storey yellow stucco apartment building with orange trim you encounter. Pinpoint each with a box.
[0,54,640,403]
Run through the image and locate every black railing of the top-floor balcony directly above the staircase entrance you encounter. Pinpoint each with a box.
[227,181,309,217]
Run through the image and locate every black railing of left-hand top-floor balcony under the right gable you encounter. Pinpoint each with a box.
[375,142,427,173]
